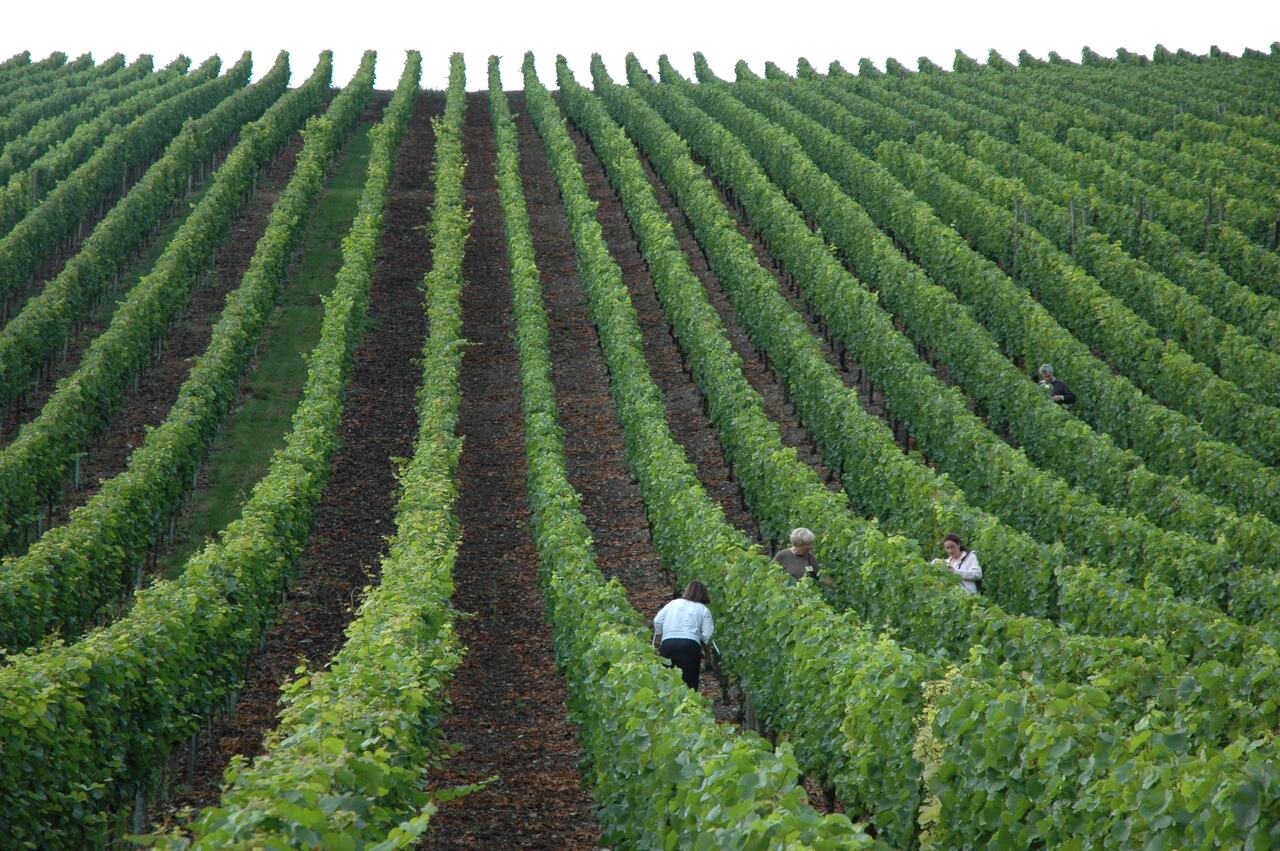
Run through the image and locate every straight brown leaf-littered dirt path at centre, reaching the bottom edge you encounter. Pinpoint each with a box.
[422,92,599,850]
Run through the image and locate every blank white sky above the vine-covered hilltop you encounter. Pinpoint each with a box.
[0,0,1280,90]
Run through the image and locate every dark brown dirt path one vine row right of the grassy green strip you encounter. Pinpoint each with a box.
[156,93,444,827]
